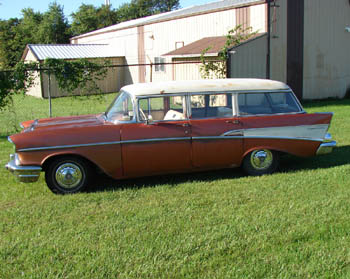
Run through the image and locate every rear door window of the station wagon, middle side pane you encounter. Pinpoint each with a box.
[191,94,233,119]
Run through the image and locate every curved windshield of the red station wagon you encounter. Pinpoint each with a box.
[105,92,134,122]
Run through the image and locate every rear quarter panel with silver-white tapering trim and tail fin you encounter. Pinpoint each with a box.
[240,113,333,157]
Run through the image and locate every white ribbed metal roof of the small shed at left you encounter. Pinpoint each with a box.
[27,44,122,60]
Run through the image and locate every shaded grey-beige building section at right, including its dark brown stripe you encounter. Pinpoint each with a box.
[269,0,350,99]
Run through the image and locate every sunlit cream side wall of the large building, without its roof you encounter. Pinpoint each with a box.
[74,4,266,84]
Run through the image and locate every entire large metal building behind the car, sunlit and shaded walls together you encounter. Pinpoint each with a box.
[24,0,350,99]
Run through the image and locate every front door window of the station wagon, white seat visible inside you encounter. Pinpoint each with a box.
[139,96,187,121]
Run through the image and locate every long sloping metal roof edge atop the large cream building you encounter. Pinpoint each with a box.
[72,0,265,39]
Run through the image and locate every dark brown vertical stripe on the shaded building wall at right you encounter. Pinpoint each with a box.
[287,0,304,100]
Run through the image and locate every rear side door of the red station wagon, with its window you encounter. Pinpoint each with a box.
[189,93,243,168]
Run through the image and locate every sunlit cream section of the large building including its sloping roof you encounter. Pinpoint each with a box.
[71,0,267,84]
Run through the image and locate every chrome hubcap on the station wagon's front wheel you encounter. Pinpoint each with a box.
[55,163,83,189]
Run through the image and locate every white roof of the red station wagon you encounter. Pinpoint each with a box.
[121,78,290,96]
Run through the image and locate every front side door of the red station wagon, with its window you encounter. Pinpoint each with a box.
[121,95,192,177]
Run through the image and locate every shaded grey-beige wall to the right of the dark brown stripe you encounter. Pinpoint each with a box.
[303,0,350,99]
